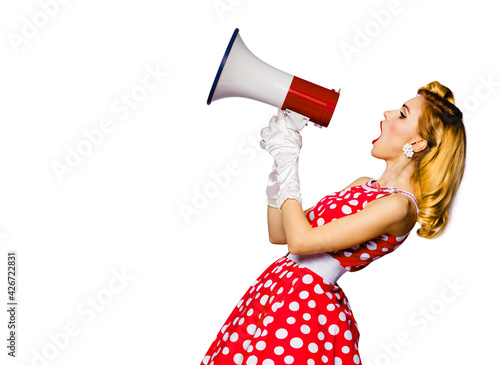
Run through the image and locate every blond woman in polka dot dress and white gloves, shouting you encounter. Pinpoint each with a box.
[202,81,466,365]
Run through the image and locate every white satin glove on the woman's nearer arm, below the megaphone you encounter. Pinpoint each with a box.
[260,110,302,209]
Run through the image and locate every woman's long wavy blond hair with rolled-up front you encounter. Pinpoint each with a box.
[411,81,466,238]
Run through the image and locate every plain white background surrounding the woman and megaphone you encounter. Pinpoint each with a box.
[0,0,500,365]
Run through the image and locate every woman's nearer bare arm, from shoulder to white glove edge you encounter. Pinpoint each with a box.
[281,194,417,255]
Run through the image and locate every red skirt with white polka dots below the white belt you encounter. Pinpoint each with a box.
[202,256,361,365]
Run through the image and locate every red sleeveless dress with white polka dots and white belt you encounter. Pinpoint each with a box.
[202,181,418,365]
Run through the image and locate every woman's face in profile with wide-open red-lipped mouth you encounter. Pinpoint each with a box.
[372,95,426,161]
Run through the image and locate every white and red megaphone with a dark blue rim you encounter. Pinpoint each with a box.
[207,28,339,130]
